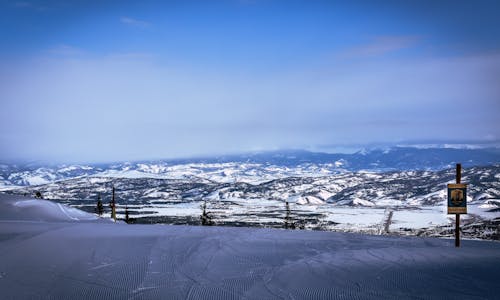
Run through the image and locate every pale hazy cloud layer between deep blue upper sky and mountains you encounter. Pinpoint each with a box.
[0,51,500,160]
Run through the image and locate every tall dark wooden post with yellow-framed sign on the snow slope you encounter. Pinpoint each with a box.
[448,164,467,247]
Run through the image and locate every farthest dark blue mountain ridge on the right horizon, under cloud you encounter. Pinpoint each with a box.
[140,147,500,171]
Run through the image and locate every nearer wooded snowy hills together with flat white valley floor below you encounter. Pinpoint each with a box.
[3,166,500,239]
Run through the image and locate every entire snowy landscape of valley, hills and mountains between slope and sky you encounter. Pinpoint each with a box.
[0,148,500,238]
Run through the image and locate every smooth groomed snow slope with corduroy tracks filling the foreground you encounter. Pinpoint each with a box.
[0,194,500,299]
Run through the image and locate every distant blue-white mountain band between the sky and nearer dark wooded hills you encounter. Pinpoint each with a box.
[0,147,500,189]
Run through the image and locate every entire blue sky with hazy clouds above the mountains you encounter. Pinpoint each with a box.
[0,0,500,161]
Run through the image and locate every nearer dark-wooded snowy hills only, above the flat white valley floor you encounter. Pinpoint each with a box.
[5,165,500,207]
